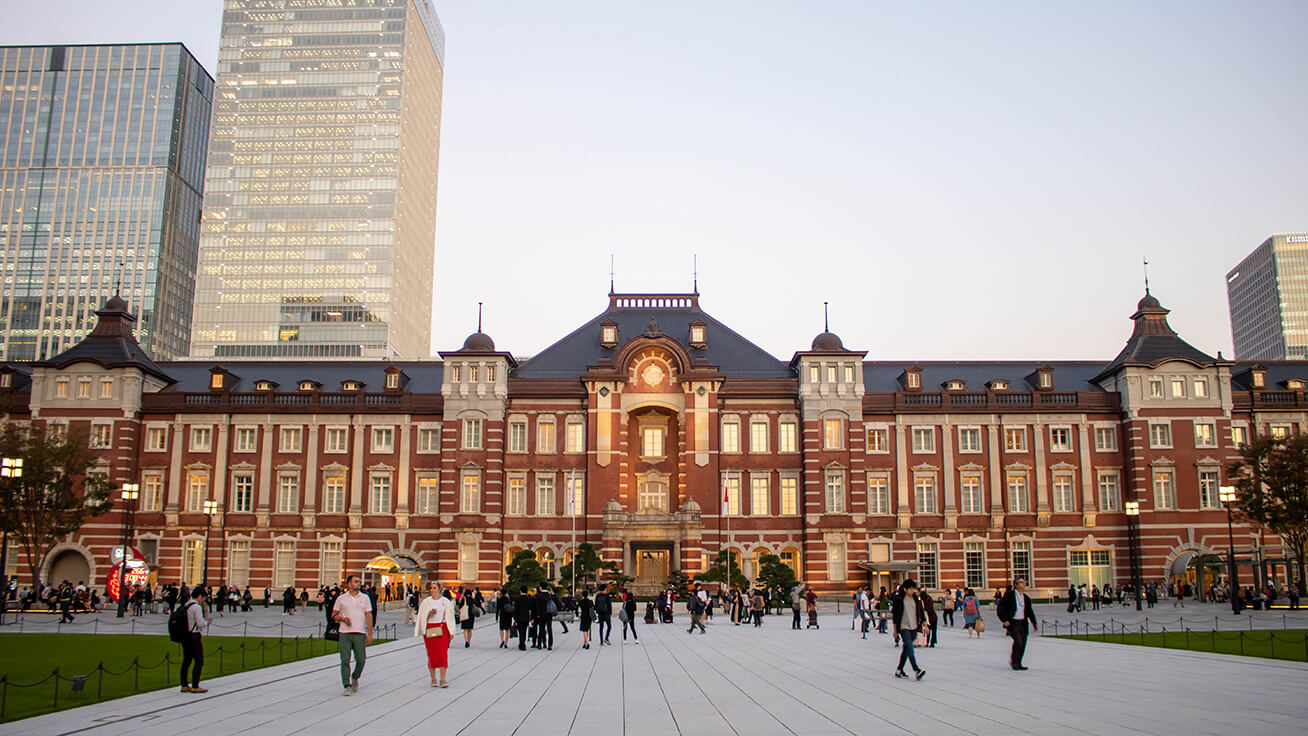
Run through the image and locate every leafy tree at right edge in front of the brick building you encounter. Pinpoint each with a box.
[1227,437,1308,594]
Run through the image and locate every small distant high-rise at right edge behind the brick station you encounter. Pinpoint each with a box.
[1227,233,1308,361]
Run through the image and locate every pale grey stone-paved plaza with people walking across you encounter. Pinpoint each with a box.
[0,607,1308,736]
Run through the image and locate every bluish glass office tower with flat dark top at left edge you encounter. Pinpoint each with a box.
[0,43,213,361]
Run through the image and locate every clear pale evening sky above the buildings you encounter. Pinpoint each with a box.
[0,0,1308,361]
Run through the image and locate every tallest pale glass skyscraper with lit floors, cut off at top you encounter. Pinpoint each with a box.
[191,0,445,360]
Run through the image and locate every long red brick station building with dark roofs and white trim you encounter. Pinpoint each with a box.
[0,288,1308,592]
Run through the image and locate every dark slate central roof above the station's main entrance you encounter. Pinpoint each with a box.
[513,294,795,378]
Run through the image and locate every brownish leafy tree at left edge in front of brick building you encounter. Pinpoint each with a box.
[0,424,114,591]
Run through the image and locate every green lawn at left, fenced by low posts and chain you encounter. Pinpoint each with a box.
[0,634,387,723]
